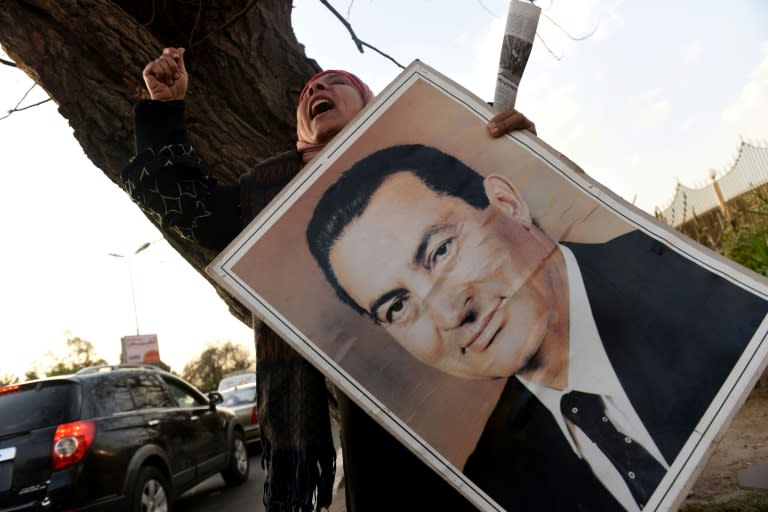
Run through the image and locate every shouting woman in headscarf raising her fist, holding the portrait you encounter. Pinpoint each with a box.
[122,48,535,512]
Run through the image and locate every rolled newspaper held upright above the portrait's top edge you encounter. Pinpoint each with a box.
[493,0,541,111]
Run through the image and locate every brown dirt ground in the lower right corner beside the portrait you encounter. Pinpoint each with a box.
[680,374,768,512]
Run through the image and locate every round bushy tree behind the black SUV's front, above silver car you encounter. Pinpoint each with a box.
[181,341,255,391]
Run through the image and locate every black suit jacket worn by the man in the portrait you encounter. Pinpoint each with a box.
[464,231,768,512]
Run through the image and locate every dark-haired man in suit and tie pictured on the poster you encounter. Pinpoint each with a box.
[306,145,767,511]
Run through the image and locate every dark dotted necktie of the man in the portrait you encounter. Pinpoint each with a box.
[560,391,666,508]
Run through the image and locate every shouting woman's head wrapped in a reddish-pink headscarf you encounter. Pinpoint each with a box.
[296,73,364,144]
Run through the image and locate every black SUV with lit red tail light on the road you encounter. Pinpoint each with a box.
[0,366,250,512]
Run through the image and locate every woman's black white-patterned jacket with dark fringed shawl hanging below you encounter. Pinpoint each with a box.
[121,100,336,511]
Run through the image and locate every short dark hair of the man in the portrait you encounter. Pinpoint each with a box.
[307,144,489,316]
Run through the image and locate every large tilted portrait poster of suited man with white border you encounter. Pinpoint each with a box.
[208,61,768,511]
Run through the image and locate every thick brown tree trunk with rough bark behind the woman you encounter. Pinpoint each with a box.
[0,0,319,324]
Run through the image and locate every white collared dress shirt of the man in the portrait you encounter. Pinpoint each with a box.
[518,245,669,512]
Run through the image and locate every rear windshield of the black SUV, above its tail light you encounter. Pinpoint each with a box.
[0,381,80,437]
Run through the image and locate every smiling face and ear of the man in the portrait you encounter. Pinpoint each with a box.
[330,171,567,378]
